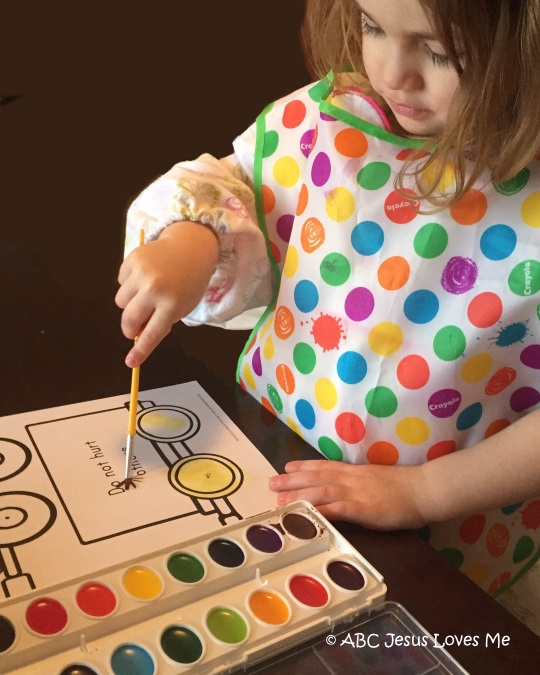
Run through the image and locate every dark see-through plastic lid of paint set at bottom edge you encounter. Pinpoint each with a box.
[251,602,467,675]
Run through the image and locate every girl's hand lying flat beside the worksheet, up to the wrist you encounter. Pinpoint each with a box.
[269,459,426,530]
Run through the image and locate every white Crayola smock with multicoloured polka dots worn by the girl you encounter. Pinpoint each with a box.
[240,82,540,596]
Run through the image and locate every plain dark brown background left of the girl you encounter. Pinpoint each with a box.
[0,0,310,402]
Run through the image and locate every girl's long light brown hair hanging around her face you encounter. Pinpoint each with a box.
[302,0,540,210]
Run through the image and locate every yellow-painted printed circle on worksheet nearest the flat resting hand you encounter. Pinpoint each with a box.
[169,454,244,499]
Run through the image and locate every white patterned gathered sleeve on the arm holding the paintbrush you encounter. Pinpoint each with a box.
[125,143,273,329]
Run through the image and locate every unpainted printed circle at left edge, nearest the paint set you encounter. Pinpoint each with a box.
[0,491,57,547]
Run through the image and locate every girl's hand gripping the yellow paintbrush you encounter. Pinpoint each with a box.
[115,222,218,368]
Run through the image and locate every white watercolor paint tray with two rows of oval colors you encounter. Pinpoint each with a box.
[0,502,386,675]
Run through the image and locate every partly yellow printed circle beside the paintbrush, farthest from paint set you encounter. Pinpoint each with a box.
[137,405,201,443]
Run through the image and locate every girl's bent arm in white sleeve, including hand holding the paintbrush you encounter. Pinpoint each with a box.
[116,155,273,367]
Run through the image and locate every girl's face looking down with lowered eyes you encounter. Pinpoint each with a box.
[357,0,459,136]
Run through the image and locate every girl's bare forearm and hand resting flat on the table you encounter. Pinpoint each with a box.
[270,410,540,530]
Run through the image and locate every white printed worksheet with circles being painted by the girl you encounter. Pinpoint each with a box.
[0,382,276,603]
